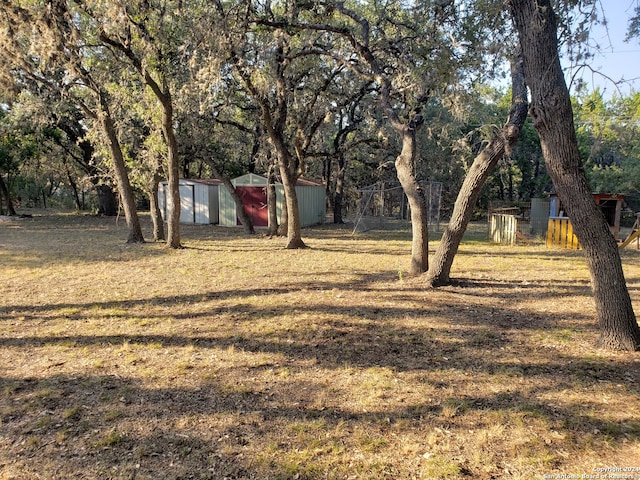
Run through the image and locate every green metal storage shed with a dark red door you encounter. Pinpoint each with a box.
[218,173,327,227]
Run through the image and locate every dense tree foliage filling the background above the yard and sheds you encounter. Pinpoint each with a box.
[0,0,640,219]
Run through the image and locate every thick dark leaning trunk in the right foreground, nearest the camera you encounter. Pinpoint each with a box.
[509,0,640,350]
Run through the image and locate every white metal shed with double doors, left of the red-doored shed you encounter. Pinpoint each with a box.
[158,178,222,224]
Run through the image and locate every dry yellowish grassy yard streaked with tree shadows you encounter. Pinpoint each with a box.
[0,214,640,479]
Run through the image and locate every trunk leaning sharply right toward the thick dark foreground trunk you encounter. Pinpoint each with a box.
[426,51,528,287]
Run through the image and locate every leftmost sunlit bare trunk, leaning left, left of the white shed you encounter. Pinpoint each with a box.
[99,107,144,243]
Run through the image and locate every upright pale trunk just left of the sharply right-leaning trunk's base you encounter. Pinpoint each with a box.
[396,125,429,275]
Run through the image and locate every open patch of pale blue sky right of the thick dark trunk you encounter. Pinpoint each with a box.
[567,0,640,97]
